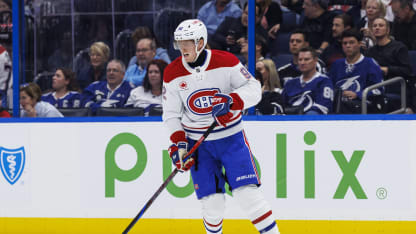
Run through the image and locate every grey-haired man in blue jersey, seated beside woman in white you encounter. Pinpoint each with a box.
[81,59,134,112]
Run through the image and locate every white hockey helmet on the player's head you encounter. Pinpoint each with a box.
[174,19,208,57]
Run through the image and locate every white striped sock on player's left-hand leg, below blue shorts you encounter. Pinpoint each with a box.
[201,193,225,234]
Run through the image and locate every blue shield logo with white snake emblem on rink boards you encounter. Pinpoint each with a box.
[0,146,26,185]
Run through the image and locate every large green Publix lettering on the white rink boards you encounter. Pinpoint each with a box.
[105,131,380,199]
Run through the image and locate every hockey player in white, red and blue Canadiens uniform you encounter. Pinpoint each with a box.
[162,19,279,234]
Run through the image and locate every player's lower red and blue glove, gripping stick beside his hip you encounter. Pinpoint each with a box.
[168,131,195,171]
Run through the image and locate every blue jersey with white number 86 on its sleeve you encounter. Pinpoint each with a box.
[283,72,334,114]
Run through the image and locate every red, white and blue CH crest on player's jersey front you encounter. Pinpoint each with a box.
[186,88,220,115]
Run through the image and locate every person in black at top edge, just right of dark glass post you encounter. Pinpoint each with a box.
[256,0,283,39]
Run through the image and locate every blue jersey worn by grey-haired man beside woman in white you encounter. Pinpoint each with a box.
[81,81,134,111]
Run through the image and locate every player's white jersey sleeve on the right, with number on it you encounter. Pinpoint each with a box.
[231,63,261,109]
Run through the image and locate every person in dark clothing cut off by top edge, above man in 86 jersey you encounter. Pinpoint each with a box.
[301,0,335,54]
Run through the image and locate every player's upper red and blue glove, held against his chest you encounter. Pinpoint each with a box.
[212,93,244,127]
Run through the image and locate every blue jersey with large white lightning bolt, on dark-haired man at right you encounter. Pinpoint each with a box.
[329,55,384,99]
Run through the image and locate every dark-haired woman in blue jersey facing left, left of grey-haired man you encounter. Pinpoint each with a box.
[41,67,81,108]
